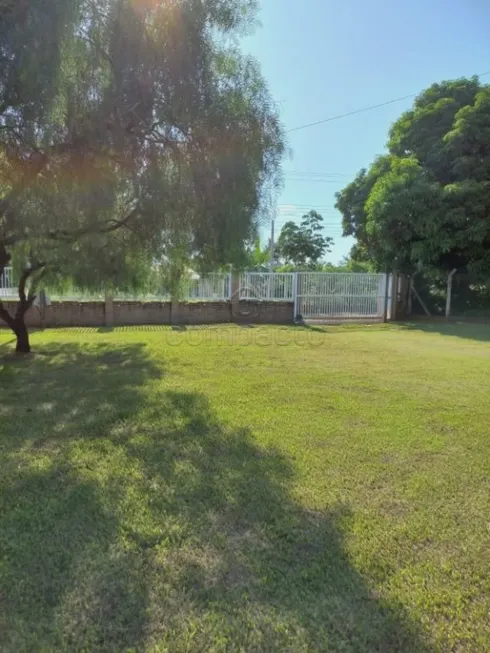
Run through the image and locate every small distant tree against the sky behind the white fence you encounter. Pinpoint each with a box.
[277,211,333,267]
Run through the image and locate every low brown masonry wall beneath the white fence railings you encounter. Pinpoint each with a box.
[0,301,294,328]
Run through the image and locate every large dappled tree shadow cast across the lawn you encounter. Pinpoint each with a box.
[0,345,428,653]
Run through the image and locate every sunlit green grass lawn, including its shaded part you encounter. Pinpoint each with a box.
[0,325,490,653]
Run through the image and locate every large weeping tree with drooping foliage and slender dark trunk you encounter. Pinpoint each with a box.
[0,0,284,351]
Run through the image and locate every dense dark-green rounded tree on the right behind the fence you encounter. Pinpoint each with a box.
[336,78,490,273]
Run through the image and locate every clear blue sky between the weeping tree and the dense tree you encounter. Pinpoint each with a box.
[243,0,490,262]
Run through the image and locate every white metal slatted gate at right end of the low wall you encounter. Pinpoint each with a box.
[294,272,389,321]
